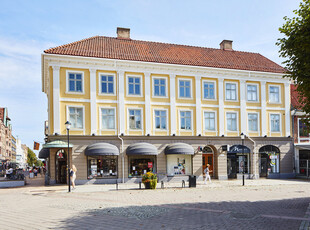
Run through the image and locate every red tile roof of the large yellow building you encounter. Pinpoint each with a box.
[44,36,285,73]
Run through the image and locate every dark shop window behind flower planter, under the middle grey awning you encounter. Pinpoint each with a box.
[128,156,156,177]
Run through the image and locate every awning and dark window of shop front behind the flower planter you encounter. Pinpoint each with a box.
[126,142,158,178]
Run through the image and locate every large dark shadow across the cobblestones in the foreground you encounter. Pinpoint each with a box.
[57,194,310,230]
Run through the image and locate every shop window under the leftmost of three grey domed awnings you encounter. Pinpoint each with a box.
[88,156,117,179]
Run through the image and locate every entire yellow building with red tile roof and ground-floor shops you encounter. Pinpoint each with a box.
[39,28,294,183]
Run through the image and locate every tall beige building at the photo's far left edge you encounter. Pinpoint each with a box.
[0,108,13,161]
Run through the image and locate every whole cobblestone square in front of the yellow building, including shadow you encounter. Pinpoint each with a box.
[0,178,310,229]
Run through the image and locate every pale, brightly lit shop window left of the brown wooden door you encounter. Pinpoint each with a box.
[167,154,192,176]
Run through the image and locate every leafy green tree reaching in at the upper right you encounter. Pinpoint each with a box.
[276,0,310,114]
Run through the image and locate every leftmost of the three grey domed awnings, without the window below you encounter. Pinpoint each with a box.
[85,142,119,156]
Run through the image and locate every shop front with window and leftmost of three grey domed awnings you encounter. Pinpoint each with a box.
[85,142,119,179]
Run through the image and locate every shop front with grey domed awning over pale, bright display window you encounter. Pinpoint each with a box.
[165,143,194,176]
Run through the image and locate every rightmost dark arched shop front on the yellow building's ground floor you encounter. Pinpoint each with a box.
[259,145,280,177]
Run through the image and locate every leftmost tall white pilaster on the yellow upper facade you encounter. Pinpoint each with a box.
[52,66,60,134]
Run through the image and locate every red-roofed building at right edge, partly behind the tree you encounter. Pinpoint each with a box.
[291,85,310,176]
